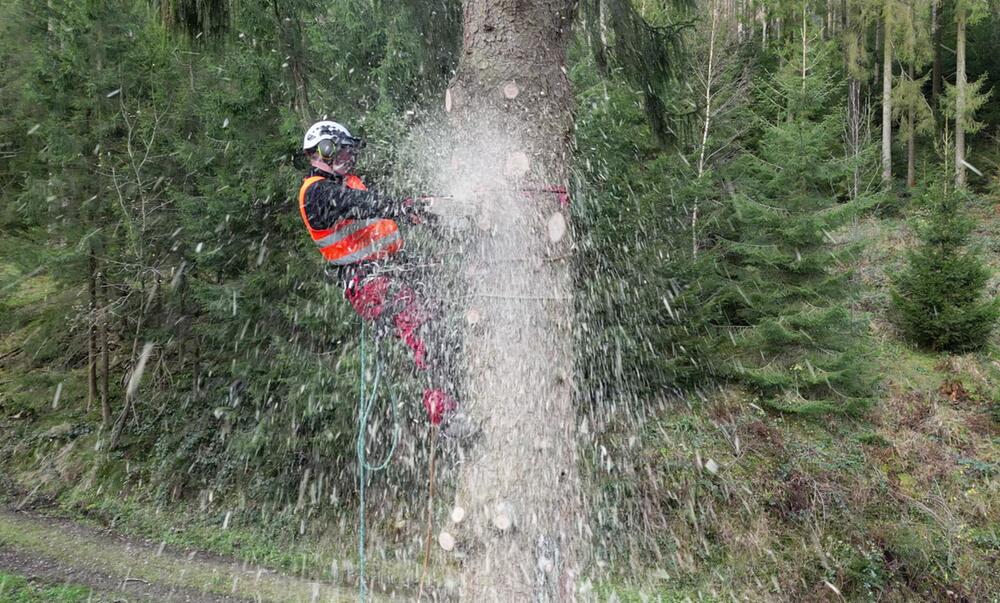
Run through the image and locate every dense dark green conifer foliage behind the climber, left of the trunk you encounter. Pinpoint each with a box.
[0,0,459,508]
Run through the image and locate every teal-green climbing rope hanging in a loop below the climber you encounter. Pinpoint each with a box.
[357,321,399,603]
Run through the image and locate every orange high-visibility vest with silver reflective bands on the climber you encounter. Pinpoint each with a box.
[299,174,403,266]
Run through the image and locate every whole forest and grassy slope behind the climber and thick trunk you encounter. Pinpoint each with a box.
[0,0,1000,600]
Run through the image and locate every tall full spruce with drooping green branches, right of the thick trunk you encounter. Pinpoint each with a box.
[713,39,871,413]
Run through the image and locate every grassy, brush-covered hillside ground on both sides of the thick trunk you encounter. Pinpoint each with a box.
[0,209,1000,601]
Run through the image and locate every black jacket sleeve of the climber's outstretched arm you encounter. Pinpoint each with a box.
[305,180,407,230]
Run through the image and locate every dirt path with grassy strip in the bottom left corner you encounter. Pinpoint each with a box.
[0,509,404,603]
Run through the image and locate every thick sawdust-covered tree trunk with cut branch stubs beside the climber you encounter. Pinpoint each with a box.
[445,0,586,601]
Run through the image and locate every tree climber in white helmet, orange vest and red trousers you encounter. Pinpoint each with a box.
[299,121,461,429]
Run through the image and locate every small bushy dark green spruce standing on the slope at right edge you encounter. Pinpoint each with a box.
[892,185,1000,352]
